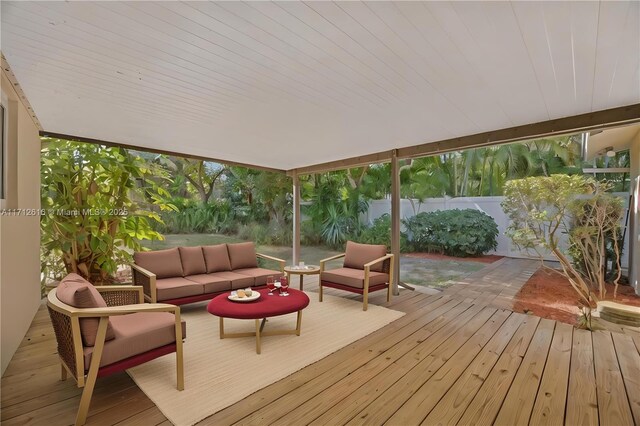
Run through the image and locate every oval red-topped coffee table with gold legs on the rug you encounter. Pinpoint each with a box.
[207,288,309,354]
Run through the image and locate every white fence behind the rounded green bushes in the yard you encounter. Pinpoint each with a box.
[361,193,629,268]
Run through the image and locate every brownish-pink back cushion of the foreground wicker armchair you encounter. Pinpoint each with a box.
[56,274,115,346]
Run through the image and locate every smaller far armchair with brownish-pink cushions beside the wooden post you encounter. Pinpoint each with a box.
[320,241,394,311]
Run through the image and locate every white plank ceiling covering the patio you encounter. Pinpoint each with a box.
[1,1,640,169]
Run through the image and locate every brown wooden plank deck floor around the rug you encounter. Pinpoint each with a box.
[1,263,640,426]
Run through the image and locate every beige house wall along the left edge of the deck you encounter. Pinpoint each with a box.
[0,70,41,374]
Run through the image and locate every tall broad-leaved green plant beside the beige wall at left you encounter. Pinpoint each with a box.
[41,138,172,284]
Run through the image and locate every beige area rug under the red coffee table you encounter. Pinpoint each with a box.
[128,292,404,426]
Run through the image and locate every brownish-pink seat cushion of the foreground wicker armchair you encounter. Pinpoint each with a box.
[84,312,187,370]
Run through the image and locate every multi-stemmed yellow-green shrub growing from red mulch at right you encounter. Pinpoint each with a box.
[502,175,622,306]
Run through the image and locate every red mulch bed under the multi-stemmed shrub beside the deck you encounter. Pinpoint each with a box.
[513,268,640,325]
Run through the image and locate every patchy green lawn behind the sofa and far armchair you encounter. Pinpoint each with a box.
[143,234,487,288]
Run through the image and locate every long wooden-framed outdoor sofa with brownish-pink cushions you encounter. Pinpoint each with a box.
[131,242,285,305]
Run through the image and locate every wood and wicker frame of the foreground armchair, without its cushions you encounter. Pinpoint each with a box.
[47,286,184,425]
